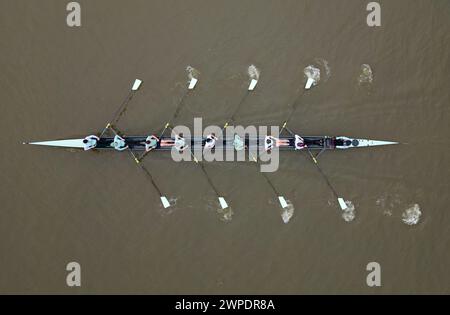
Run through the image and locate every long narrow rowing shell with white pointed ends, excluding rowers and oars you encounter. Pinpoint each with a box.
[26,136,398,151]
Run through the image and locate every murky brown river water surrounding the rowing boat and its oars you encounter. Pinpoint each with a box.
[0,0,450,294]
